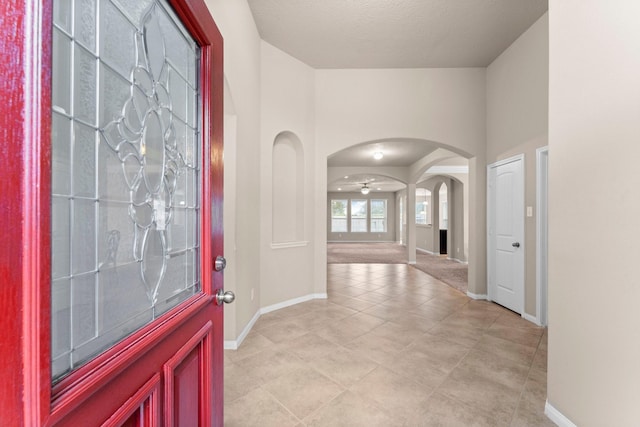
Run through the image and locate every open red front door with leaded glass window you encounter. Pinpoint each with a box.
[0,0,223,426]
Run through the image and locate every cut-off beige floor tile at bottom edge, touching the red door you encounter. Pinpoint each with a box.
[224,388,300,427]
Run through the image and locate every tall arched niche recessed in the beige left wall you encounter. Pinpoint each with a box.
[271,131,305,243]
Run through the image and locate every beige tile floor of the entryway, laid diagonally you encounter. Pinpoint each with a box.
[225,264,554,427]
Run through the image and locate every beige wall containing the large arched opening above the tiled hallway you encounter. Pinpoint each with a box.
[315,68,486,294]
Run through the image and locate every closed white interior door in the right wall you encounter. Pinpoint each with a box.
[487,156,524,314]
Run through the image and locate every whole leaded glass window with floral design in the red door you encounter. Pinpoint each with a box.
[51,0,202,381]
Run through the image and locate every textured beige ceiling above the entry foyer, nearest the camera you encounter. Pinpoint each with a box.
[249,0,548,68]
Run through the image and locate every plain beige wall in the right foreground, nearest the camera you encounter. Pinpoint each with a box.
[547,0,640,427]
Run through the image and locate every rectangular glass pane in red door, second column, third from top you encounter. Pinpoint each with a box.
[73,122,97,198]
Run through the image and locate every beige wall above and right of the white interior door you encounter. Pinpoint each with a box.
[487,14,553,317]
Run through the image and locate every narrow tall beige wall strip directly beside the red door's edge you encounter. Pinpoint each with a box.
[206,0,260,339]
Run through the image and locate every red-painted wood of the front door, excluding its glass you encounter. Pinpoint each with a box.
[0,0,223,426]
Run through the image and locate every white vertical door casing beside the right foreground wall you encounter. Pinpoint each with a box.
[536,146,549,326]
